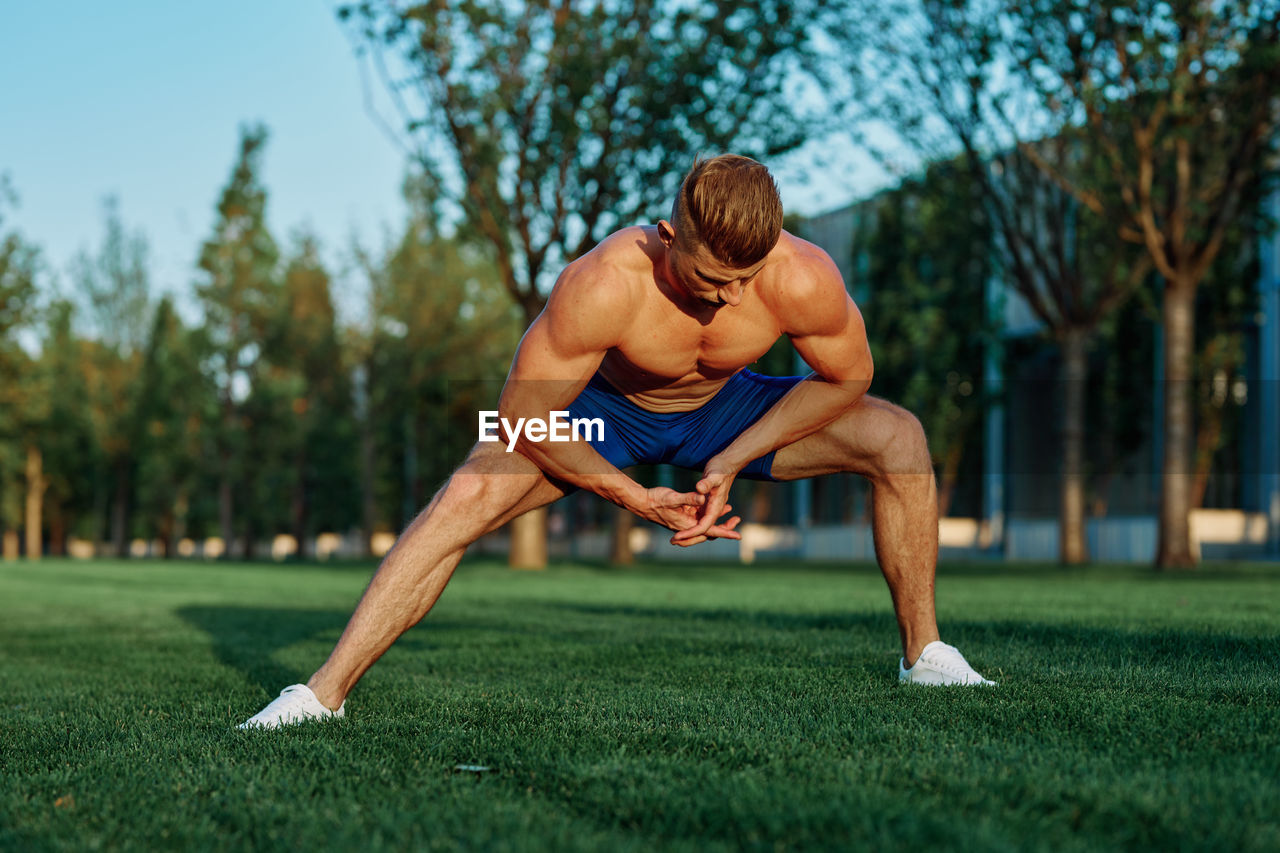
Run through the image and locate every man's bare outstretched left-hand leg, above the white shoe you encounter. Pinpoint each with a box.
[307,443,566,708]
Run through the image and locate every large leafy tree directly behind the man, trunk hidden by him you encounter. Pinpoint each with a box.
[338,0,812,565]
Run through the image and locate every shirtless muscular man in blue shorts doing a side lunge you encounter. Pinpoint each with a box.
[243,155,992,726]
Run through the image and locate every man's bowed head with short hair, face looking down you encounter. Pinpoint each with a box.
[658,154,782,305]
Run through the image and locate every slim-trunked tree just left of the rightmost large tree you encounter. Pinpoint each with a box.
[833,0,1149,564]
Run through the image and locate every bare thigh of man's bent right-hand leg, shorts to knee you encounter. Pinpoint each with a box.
[771,394,932,480]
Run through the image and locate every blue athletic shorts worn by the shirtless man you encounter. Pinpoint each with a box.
[568,370,804,480]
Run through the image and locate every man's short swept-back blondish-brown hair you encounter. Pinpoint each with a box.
[671,154,782,269]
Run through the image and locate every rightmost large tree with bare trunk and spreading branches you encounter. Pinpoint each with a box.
[1005,0,1280,569]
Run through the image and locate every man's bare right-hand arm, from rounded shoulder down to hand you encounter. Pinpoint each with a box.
[672,264,873,546]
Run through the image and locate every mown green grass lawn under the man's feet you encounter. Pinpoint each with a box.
[0,561,1280,850]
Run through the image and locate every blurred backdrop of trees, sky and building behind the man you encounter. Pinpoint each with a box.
[0,0,1280,567]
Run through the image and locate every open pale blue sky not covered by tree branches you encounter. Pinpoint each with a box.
[0,0,873,318]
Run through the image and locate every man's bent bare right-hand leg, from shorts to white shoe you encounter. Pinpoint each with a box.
[772,397,938,665]
